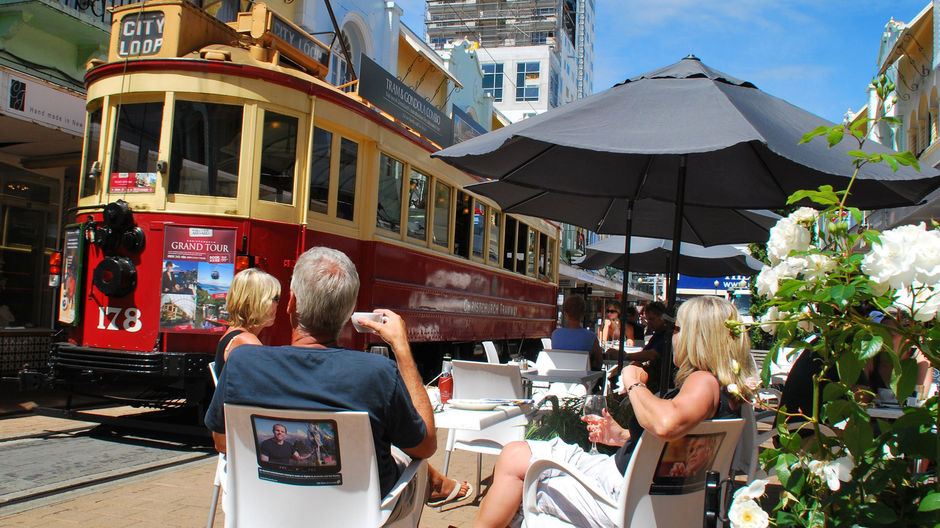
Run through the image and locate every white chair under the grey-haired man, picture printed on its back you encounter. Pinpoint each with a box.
[225,404,428,528]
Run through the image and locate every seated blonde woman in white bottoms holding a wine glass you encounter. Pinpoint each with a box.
[474,297,756,528]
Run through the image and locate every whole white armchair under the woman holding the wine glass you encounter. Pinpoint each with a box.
[522,418,744,528]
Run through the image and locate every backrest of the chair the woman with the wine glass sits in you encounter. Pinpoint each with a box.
[614,418,745,526]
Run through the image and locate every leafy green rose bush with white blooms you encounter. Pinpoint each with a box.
[729,79,940,528]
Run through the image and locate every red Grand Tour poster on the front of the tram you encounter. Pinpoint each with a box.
[160,225,235,332]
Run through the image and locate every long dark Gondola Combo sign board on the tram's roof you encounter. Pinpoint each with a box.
[359,55,454,147]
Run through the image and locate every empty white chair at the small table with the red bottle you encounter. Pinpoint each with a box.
[443,360,531,500]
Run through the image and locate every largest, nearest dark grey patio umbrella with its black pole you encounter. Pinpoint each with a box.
[432,56,940,387]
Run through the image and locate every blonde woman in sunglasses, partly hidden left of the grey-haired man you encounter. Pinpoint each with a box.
[215,268,281,376]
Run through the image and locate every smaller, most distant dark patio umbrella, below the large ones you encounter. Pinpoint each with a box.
[574,235,764,277]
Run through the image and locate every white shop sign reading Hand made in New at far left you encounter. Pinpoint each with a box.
[0,70,85,137]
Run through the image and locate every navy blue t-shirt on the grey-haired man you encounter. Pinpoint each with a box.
[206,345,427,495]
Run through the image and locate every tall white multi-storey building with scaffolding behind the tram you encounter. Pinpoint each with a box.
[425,0,594,122]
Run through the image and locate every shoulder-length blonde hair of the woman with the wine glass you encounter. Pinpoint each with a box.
[673,296,757,400]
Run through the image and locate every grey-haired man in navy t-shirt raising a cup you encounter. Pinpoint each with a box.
[206,247,441,495]
